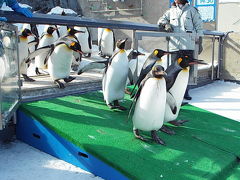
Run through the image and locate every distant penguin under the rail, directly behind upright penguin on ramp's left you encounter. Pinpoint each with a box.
[99,28,115,58]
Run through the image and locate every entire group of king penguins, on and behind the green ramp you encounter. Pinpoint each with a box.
[15,17,204,145]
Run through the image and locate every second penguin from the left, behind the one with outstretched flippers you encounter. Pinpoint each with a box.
[35,25,57,75]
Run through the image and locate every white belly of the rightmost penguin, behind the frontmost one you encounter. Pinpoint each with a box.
[164,69,189,122]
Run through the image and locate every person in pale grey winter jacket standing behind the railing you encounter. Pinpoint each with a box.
[157,0,203,100]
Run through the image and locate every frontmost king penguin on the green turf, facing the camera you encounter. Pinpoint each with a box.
[130,65,166,145]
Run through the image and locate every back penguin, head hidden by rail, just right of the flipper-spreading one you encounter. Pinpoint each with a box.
[74,26,92,57]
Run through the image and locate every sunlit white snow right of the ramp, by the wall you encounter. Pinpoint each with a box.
[190,81,240,122]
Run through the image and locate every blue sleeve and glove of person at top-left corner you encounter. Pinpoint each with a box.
[0,0,32,21]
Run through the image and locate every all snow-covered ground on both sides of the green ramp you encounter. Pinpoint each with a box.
[0,81,240,180]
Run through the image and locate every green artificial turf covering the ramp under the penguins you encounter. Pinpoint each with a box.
[21,92,240,180]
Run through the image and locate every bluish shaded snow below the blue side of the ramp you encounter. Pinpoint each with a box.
[0,140,101,180]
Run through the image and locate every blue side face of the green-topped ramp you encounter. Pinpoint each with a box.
[16,110,128,180]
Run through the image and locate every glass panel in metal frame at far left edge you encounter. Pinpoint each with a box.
[0,26,20,126]
